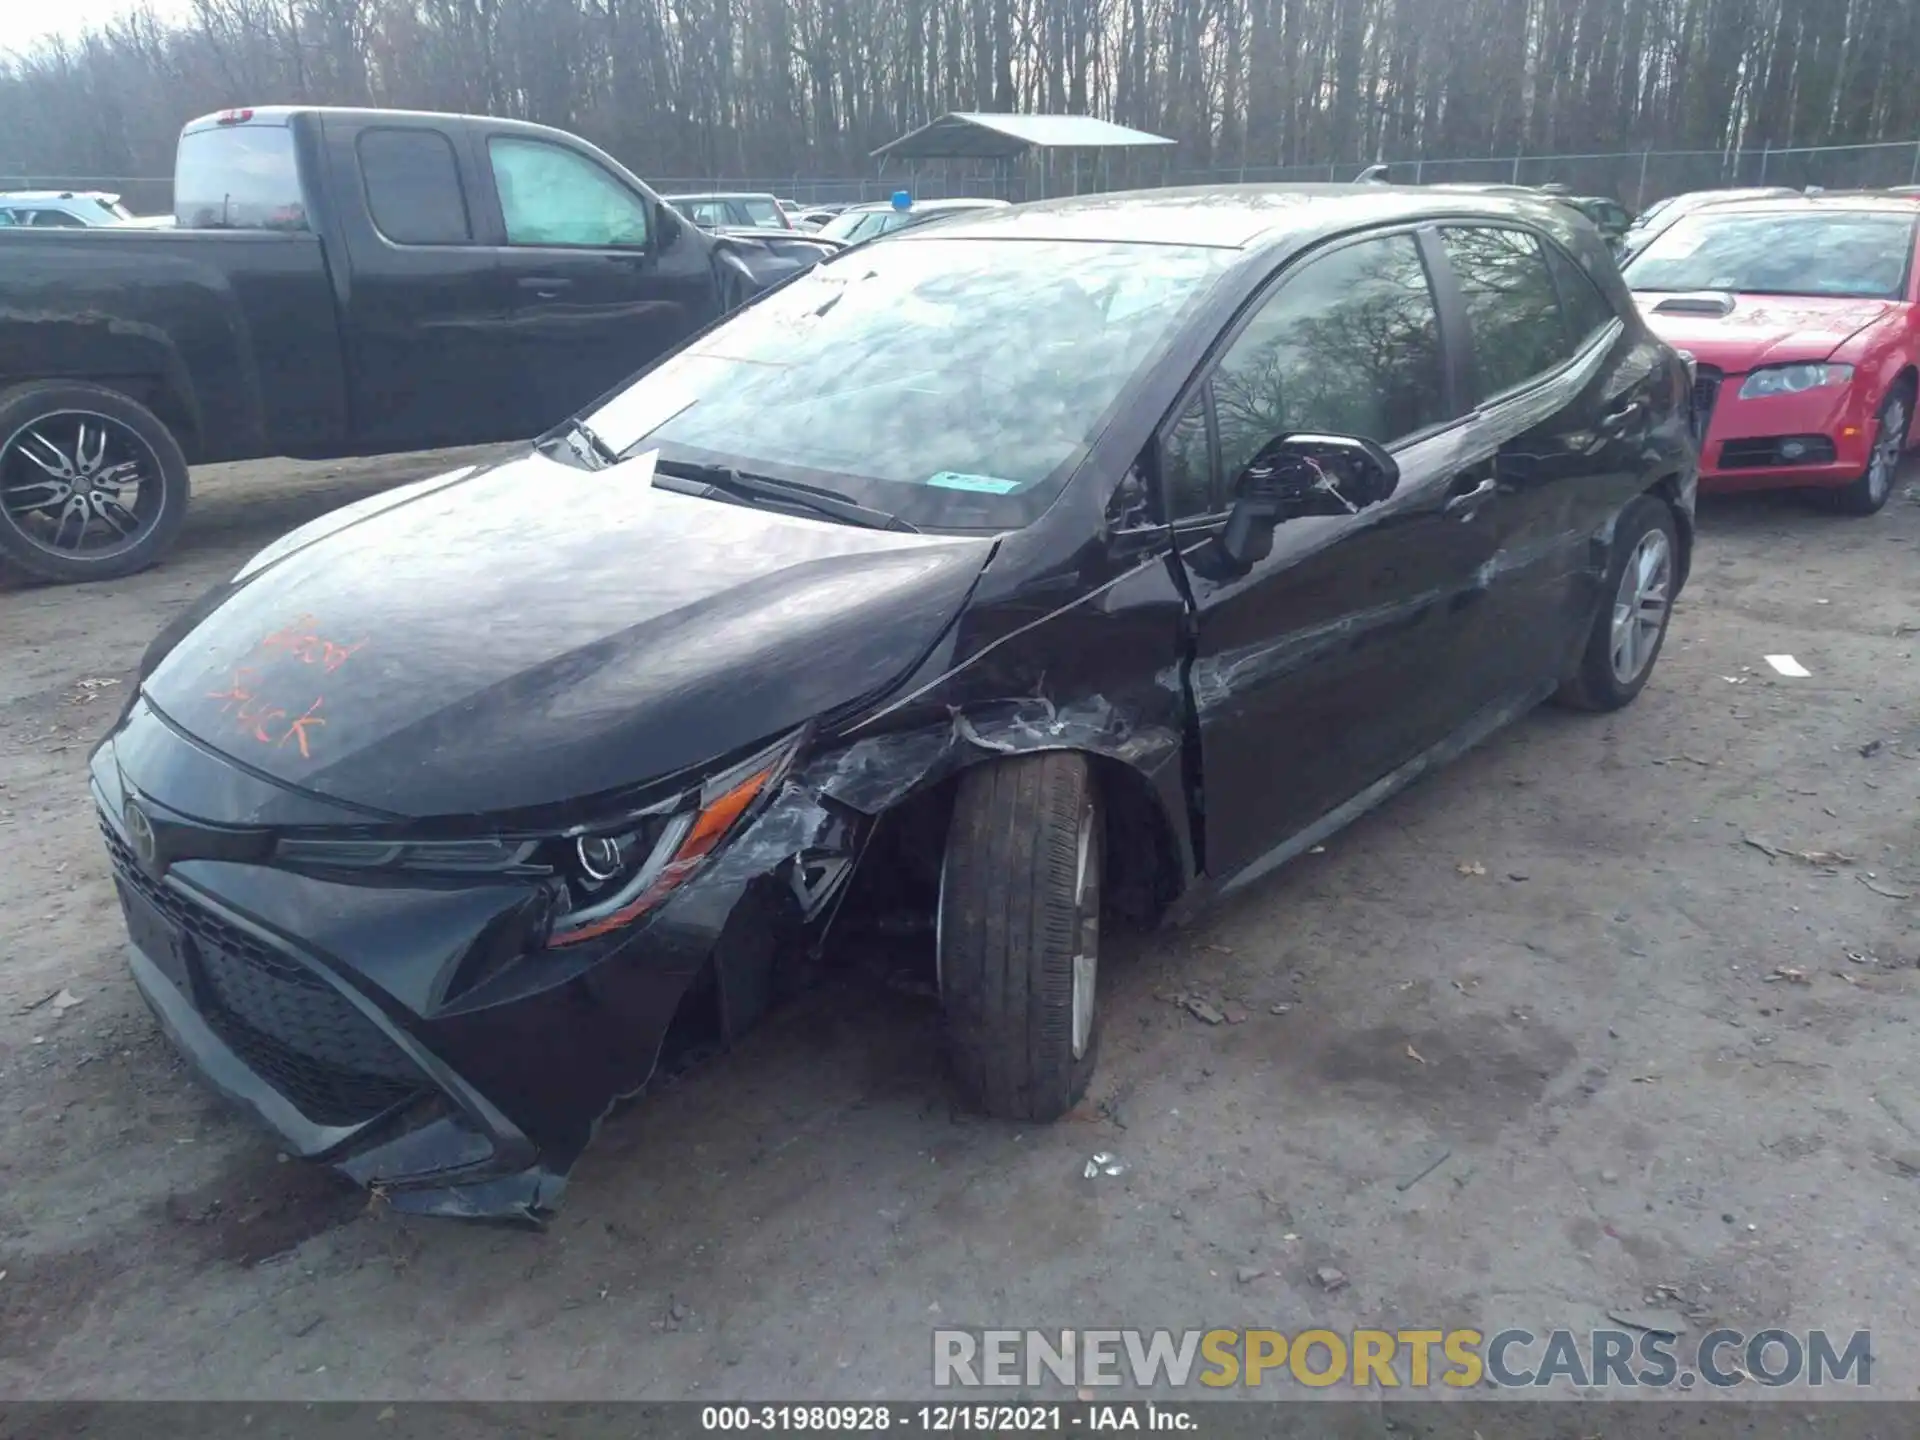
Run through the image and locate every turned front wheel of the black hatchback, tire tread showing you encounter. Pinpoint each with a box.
[935,753,1104,1121]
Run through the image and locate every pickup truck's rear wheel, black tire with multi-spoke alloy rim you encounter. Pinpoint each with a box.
[0,380,188,584]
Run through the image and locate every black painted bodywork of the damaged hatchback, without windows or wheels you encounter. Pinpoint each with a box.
[92,186,1695,1217]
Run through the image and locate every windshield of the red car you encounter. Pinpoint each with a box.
[1626,211,1914,300]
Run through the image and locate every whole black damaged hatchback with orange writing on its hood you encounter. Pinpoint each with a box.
[92,186,1697,1217]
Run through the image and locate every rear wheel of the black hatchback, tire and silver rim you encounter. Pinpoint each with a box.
[1555,495,1680,710]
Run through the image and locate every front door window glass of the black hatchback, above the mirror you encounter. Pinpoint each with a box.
[1213,234,1448,484]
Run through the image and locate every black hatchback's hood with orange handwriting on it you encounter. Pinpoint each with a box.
[142,453,993,820]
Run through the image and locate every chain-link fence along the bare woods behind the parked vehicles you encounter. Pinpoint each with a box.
[22,140,1920,215]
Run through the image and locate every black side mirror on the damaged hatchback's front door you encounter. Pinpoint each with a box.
[1219,434,1400,572]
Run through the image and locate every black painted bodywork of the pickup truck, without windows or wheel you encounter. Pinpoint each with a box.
[0,108,787,463]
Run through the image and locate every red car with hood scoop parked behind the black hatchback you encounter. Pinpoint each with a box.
[1626,196,1920,515]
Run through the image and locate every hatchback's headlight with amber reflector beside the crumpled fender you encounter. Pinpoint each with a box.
[547,732,801,947]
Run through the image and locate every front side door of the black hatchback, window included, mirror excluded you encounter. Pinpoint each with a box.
[1162,230,1500,881]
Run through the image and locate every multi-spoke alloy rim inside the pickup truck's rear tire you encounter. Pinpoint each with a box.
[0,411,163,559]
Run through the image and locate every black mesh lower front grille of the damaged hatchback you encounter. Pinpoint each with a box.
[100,820,426,1125]
